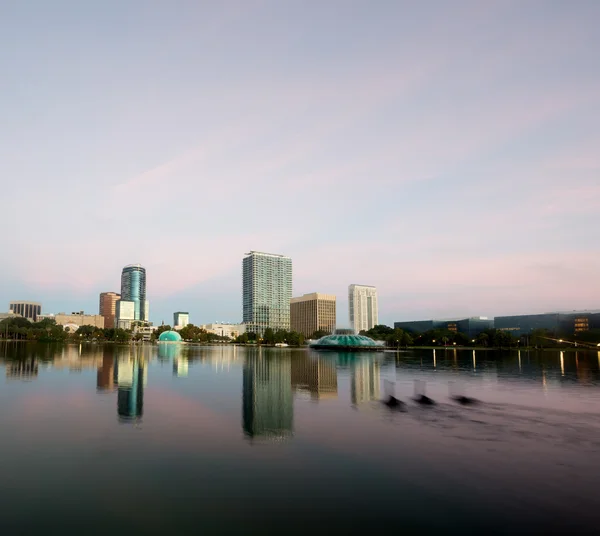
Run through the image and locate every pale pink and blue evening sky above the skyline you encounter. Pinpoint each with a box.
[0,0,600,325]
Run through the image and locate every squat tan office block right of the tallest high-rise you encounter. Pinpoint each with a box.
[290,292,335,337]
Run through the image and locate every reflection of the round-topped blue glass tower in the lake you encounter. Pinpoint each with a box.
[115,355,148,421]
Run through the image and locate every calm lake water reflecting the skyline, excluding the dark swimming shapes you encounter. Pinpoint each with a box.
[0,343,600,535]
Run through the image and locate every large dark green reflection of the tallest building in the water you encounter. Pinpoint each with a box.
[242,353,294,439]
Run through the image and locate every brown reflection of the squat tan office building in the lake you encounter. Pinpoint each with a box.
[291,352,338,400]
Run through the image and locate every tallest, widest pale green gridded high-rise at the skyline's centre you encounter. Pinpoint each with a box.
[242,251,292,336]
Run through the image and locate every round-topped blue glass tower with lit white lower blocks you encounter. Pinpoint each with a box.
[115,264,150,329]
